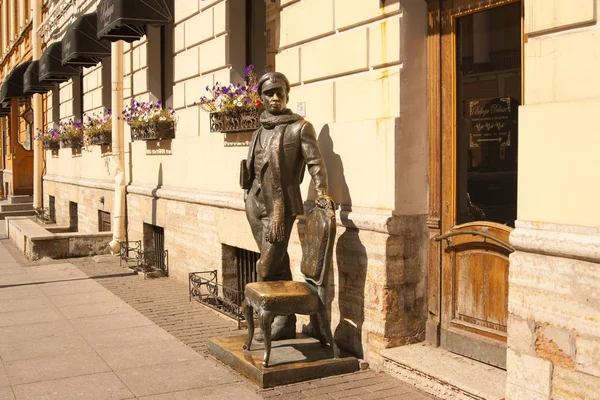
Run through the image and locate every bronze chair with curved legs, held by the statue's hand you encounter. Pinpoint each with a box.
[242,205,340,368]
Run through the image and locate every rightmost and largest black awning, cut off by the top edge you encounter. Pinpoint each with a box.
[96,0,173,42]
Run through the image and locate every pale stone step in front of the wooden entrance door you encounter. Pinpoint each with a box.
[382,343,506,400]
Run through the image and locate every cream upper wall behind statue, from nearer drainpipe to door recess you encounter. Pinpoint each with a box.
[125,0,412,210]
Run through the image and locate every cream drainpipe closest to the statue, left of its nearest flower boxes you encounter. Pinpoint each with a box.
[108,40,126,254]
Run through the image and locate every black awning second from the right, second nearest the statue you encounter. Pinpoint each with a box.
[62,13,110,67]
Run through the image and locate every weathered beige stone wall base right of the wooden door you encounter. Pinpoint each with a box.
[506,222,600,400]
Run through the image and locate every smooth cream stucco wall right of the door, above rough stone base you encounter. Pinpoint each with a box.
[518,0,600,226]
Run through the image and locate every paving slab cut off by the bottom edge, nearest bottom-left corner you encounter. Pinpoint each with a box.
[15,372,134,400]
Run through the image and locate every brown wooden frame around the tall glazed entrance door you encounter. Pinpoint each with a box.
[425,0,527,347]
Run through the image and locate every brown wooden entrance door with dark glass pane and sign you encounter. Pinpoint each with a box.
[430,0,522,368]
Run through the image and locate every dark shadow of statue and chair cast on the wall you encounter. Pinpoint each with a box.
[301,124,367,358]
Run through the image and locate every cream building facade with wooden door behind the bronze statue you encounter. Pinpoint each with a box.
[2,0,600,399]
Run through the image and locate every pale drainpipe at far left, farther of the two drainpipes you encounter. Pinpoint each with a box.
[31,0,44,210]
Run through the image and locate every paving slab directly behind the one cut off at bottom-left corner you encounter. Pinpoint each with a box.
[4,351,110,385]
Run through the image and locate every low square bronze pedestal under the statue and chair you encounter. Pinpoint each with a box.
[208,335,359,388]
